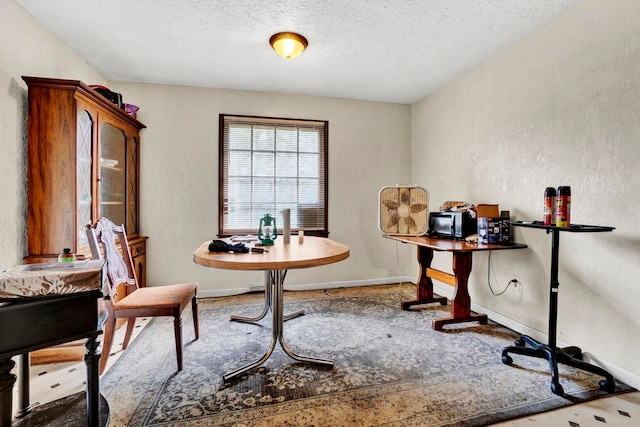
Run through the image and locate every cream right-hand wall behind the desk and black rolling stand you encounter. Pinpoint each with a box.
[412,0,640,386]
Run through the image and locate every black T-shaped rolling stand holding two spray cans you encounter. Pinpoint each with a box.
[502,221,615,396]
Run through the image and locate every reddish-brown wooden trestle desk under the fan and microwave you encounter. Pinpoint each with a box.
[383,234,527,331]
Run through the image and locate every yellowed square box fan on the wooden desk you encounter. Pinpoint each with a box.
[378,185,429,236]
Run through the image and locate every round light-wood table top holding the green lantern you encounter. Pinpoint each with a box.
[193,236,349,270]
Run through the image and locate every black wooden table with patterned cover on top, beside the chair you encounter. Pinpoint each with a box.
[0,261,109,427]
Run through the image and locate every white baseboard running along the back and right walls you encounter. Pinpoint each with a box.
[198,276,640,389]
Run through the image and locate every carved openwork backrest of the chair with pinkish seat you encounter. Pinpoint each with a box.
[86,217,138,301]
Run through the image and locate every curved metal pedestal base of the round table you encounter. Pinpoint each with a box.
[222,270,333,381]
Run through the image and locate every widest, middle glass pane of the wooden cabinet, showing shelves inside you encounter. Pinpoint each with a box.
[98,123,128,227]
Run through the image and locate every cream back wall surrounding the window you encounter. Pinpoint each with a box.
[110,83,412,295]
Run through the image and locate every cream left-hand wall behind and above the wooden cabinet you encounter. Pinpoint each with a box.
[0,0,106,271]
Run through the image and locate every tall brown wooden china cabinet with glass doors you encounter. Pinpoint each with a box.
[23,77,147,286]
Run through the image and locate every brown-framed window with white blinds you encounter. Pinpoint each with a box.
[218,114,329,237]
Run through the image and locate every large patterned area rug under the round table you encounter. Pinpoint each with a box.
[100,284,630,427]
